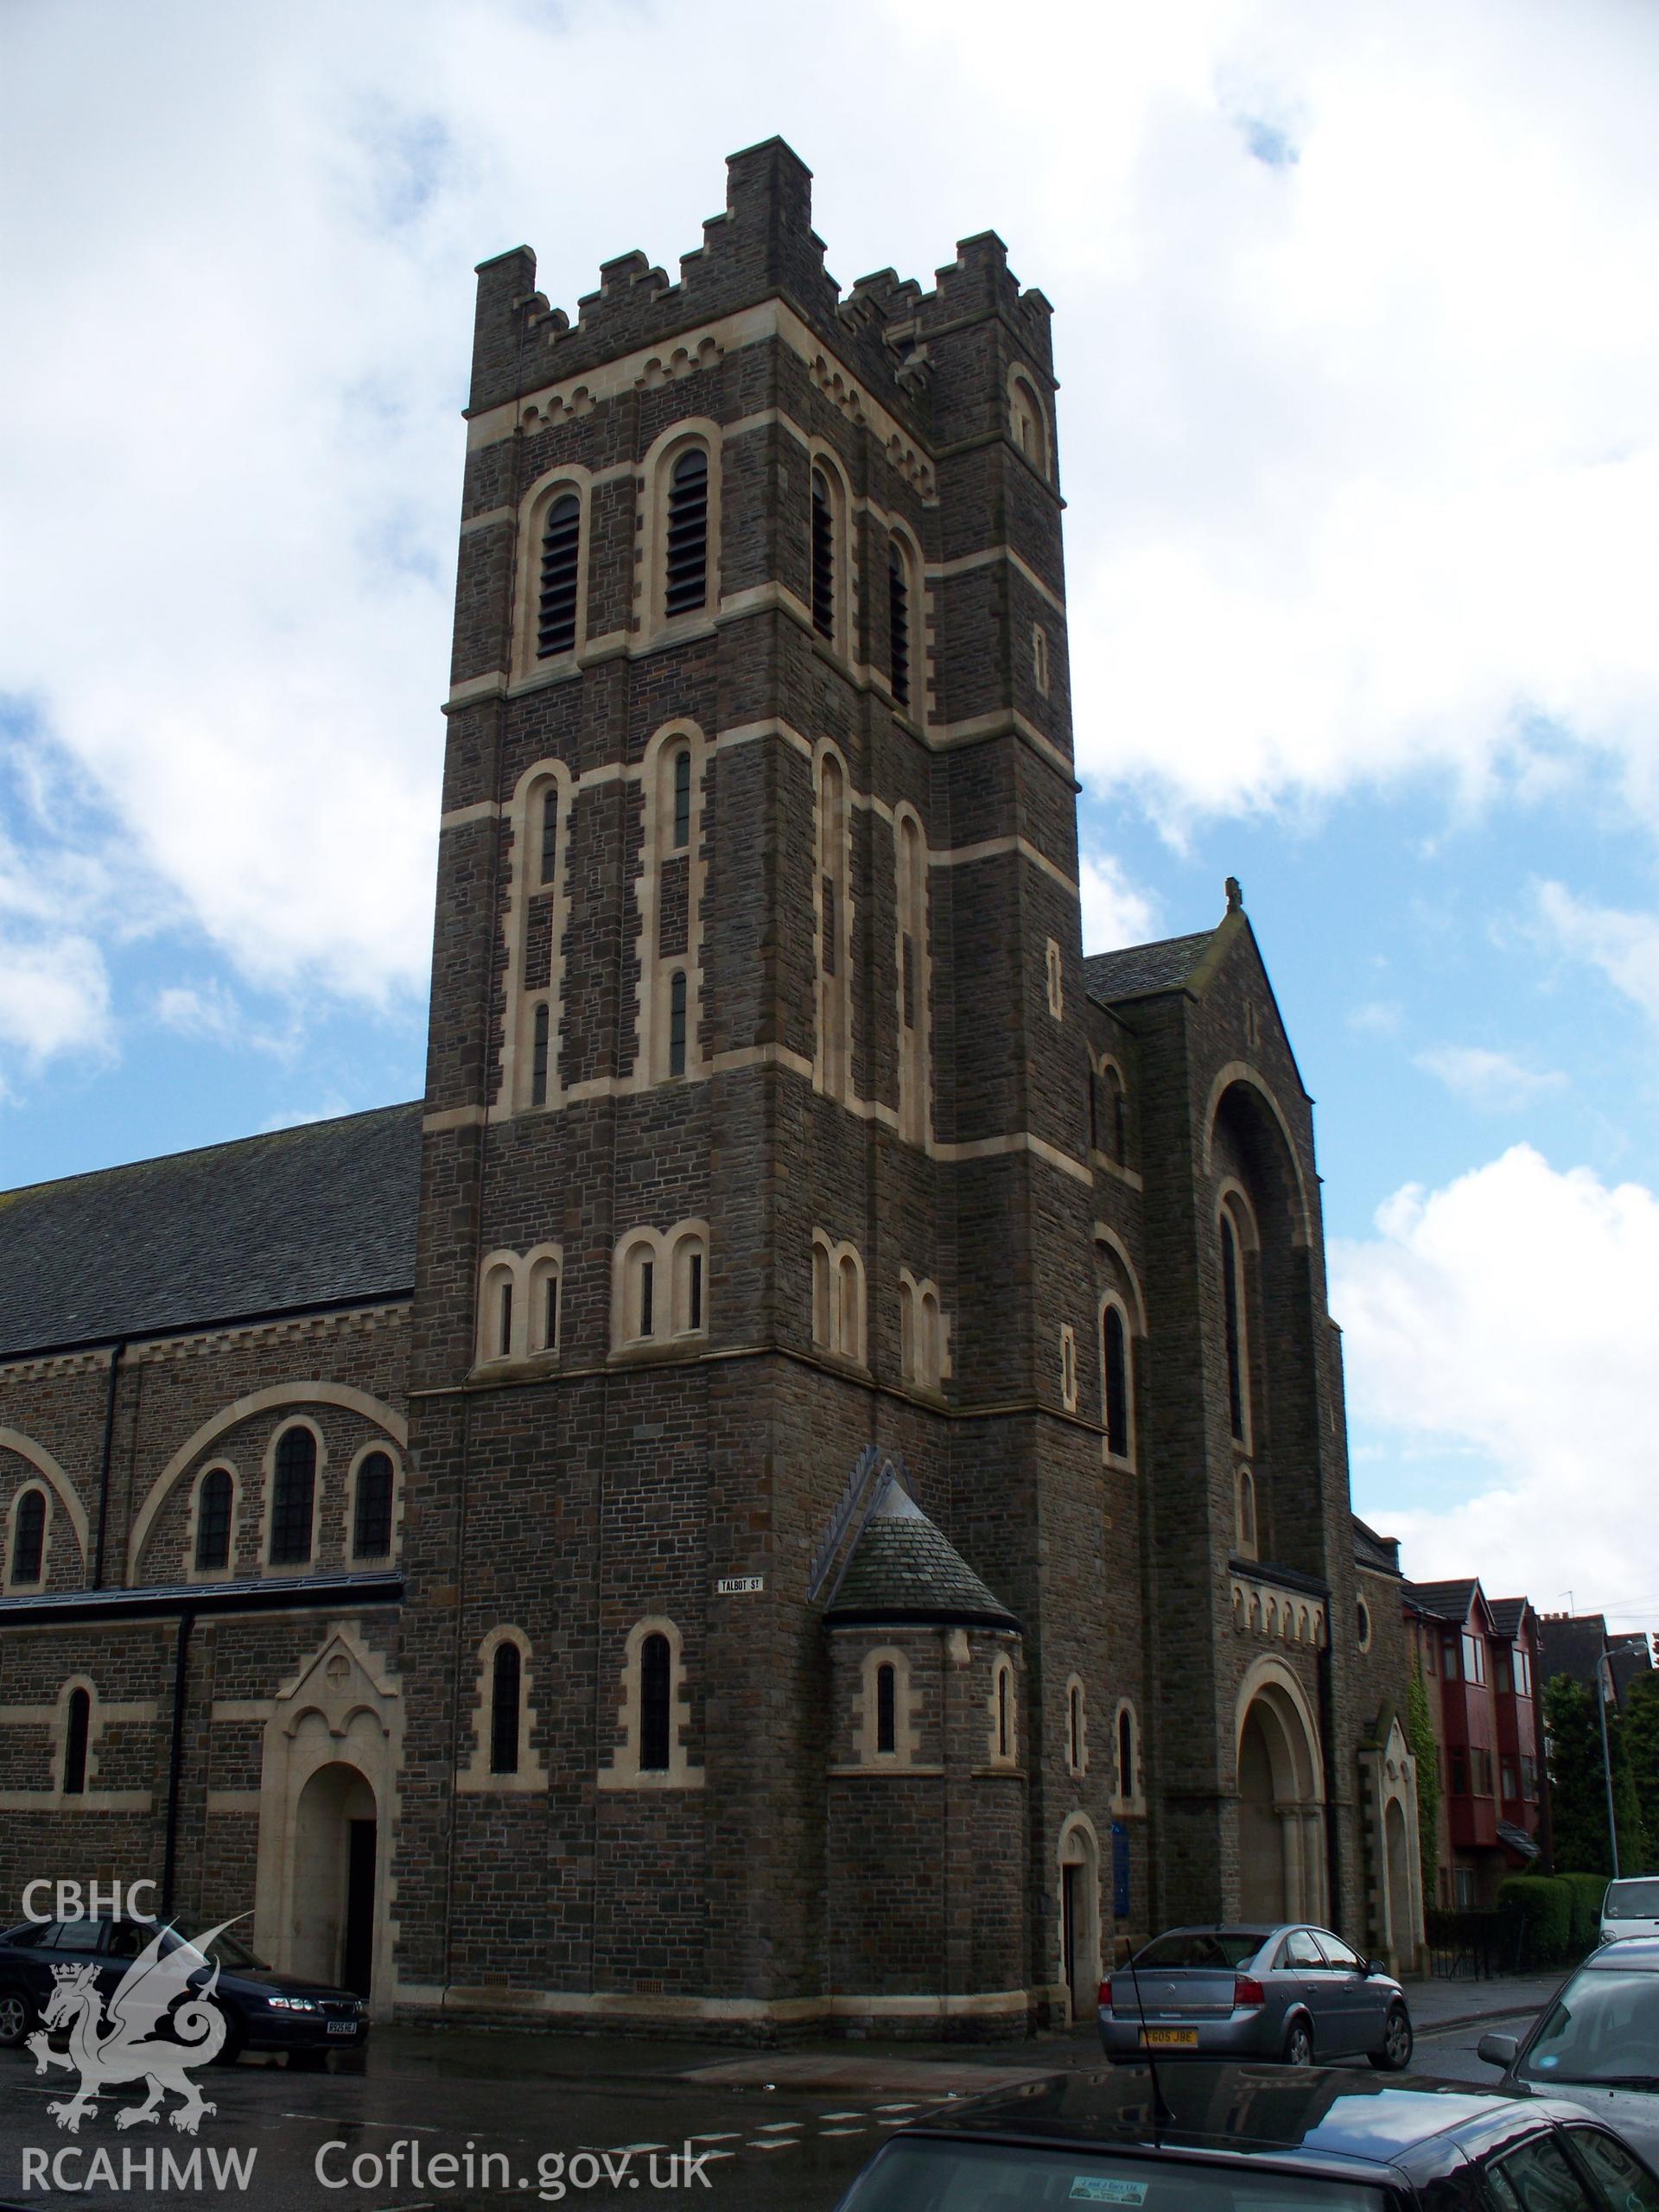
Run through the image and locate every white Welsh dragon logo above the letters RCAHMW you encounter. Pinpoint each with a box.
[29,1920,230,2134]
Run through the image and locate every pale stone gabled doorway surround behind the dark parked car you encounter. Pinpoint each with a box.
[254,1621,403,2015]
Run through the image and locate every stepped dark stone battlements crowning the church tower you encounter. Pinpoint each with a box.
[469,137,1053,420]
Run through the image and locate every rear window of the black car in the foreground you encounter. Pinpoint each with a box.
[841,2139,1395,2212]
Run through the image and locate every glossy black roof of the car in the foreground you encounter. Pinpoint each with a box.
[916,2059,1584,2181]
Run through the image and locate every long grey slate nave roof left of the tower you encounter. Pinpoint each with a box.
[0,1102,420,1356]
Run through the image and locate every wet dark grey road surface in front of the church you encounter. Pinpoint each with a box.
[0,1978,1557,2212]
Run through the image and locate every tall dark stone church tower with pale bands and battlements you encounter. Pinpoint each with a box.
[396,142,1122,2019]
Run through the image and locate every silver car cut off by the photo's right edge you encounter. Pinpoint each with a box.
[1478,1936,1659,2159]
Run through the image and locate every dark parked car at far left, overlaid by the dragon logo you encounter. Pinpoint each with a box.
[0,1918,370,2066]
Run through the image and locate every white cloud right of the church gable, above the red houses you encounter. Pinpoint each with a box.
[1332,1144,1659,1611]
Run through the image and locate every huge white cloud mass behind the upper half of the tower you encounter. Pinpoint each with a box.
[0,0,1659,1057]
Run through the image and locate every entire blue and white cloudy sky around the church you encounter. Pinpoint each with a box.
[0,0,1659,1628]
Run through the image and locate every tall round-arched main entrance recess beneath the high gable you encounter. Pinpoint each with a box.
[1234,1655,1327,1923]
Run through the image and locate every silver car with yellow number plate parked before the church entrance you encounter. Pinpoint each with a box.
[1099,1923,1411,2073]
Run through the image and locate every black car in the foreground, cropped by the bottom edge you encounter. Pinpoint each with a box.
[838,2059,1659,2212]
